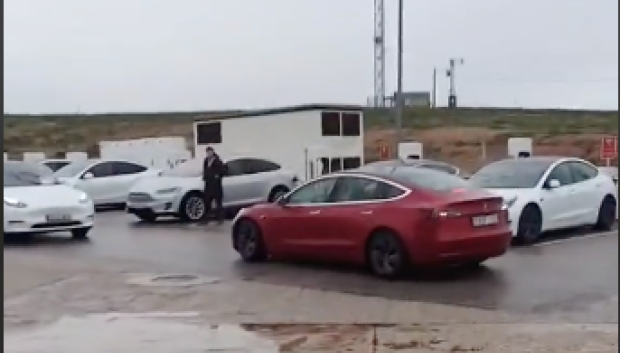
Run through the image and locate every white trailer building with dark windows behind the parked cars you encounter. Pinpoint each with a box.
[194,105,364,180]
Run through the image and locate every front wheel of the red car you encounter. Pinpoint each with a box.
[233,219,267,262]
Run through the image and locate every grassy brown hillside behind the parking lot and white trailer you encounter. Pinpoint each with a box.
[4,108,618,169]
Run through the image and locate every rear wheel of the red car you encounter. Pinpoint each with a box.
[366,231,409,279]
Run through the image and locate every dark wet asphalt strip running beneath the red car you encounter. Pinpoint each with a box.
[4,212,618,323]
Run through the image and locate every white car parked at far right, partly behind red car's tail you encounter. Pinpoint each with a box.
[470,157,618,244]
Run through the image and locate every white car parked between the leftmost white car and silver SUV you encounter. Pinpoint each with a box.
[54,159,160,206]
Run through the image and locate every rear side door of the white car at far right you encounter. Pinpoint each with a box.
[568,161,606,221]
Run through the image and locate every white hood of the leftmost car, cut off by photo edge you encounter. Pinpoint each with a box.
[4,185,84,207]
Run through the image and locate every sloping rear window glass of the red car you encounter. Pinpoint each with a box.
[380,166,472,191]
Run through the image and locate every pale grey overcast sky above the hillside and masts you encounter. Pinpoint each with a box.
[4,0,618,112]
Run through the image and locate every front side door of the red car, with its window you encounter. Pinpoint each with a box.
[264,177,338,258]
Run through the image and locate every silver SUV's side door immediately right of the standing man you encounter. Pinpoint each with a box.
[222,158,260,207]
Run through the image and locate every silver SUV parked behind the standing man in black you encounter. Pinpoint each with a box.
[127,158,298,222]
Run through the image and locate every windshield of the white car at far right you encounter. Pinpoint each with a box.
[469,159,551,189]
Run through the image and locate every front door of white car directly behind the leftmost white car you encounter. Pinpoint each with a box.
[76,162,115,205]
